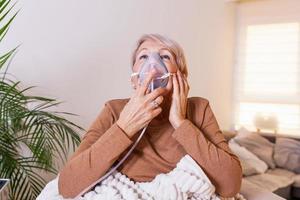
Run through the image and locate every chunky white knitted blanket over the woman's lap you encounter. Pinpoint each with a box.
[37,155,245,200]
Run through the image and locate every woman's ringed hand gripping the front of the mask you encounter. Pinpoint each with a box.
[116,71,166,138]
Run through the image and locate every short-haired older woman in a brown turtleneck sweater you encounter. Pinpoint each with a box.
[58,34,242,198]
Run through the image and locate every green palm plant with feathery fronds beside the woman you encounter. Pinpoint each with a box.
[0,0,83,200]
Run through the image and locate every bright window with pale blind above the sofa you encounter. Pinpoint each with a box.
[234,21,300,136]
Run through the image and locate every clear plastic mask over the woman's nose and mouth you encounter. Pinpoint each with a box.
[131,52,170,91]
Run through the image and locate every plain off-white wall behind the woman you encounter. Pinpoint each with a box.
[5,0,235,134]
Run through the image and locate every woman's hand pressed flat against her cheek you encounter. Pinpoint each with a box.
[169,70,190,129]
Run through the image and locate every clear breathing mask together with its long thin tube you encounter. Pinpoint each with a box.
[75,52,171,200]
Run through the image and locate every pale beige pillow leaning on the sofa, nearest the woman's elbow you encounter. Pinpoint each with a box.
[234,128,276,168]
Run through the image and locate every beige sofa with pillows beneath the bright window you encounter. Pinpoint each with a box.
[223,130,300,200]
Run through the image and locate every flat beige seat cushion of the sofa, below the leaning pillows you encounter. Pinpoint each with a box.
[245,169,295,192]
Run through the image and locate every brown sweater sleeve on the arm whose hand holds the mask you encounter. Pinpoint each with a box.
[58,101,132,198]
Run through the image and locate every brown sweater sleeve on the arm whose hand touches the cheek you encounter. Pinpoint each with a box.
[172,102,242,197]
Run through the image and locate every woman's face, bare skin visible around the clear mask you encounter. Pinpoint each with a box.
[132,40,178,95]
